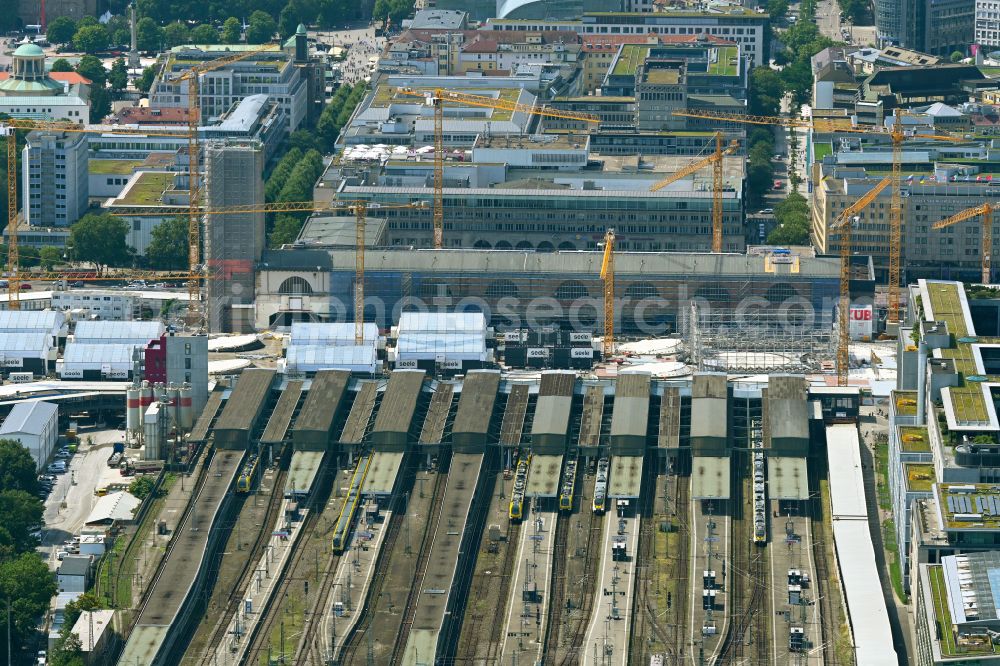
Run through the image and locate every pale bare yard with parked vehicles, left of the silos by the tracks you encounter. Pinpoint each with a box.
[39,430,134,569]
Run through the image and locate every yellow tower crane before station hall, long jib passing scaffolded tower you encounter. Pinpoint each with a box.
[120,199,427,345]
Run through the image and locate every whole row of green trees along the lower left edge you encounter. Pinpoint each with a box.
[0,440,56,663]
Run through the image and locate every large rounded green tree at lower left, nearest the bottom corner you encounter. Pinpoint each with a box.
[0,551,56,653]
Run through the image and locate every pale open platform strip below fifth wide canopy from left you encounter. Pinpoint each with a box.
[495,511,556,664]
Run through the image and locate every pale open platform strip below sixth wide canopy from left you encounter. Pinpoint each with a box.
[581,516,639,666]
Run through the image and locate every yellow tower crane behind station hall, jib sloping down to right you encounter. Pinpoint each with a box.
[398,88,600,250]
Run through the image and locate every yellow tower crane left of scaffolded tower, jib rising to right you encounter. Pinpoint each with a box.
[164,44,280,319]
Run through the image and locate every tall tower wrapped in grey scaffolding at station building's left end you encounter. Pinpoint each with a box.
[203,140,264,333]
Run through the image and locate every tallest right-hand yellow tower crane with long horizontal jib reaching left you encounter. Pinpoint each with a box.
[673,109,964,324]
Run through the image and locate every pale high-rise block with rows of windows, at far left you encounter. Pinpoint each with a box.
[22,132,89,227]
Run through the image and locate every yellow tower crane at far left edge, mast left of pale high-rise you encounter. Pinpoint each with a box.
[0,118,188,310]
